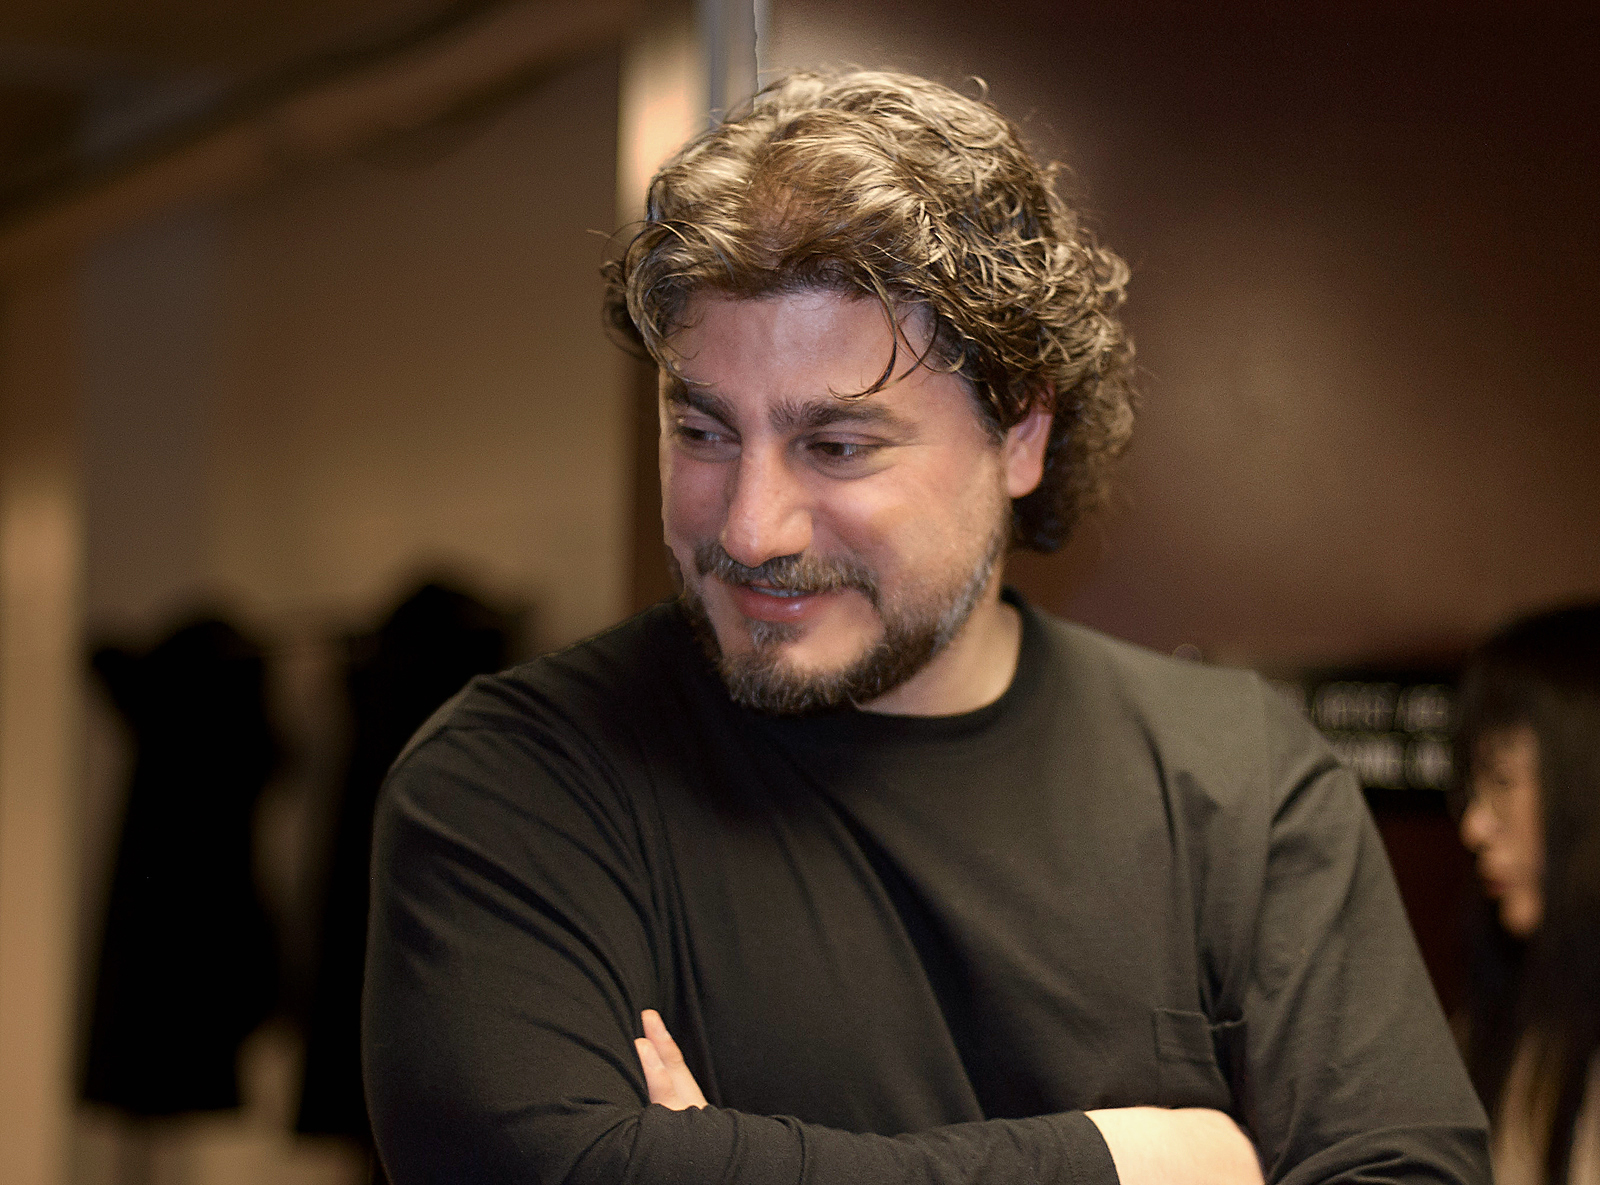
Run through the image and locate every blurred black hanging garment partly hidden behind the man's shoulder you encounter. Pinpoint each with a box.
[296,582,515,1140]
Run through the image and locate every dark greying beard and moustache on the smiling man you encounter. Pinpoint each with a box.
[669,533,1005,715]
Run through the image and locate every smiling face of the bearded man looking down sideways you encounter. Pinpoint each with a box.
[661,289,1038,712]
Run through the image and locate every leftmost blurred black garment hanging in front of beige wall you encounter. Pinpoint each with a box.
[83,619,277,1116]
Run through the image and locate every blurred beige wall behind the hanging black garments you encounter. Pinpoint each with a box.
[68,53,634,1185]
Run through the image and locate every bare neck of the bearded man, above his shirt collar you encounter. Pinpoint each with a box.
[861,588,1022,716]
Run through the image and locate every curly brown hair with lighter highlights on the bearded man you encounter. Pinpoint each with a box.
[605,72,1134,552]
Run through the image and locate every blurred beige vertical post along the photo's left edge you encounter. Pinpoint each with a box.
[0,261,83,1185]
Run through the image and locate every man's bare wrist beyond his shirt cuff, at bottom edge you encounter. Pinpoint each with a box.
[1086,1107,1262,1185]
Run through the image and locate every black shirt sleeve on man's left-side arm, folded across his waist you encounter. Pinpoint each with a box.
[363,728,1117,1185]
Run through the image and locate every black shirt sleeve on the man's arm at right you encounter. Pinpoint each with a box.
[1228,688,1490,1185]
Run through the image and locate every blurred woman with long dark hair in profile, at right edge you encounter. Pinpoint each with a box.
[1456,603,1600,1185]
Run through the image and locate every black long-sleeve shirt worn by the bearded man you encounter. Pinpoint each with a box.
[365,604,1488,1185]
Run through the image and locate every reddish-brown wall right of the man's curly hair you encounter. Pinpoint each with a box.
[766,0,1600,662]
